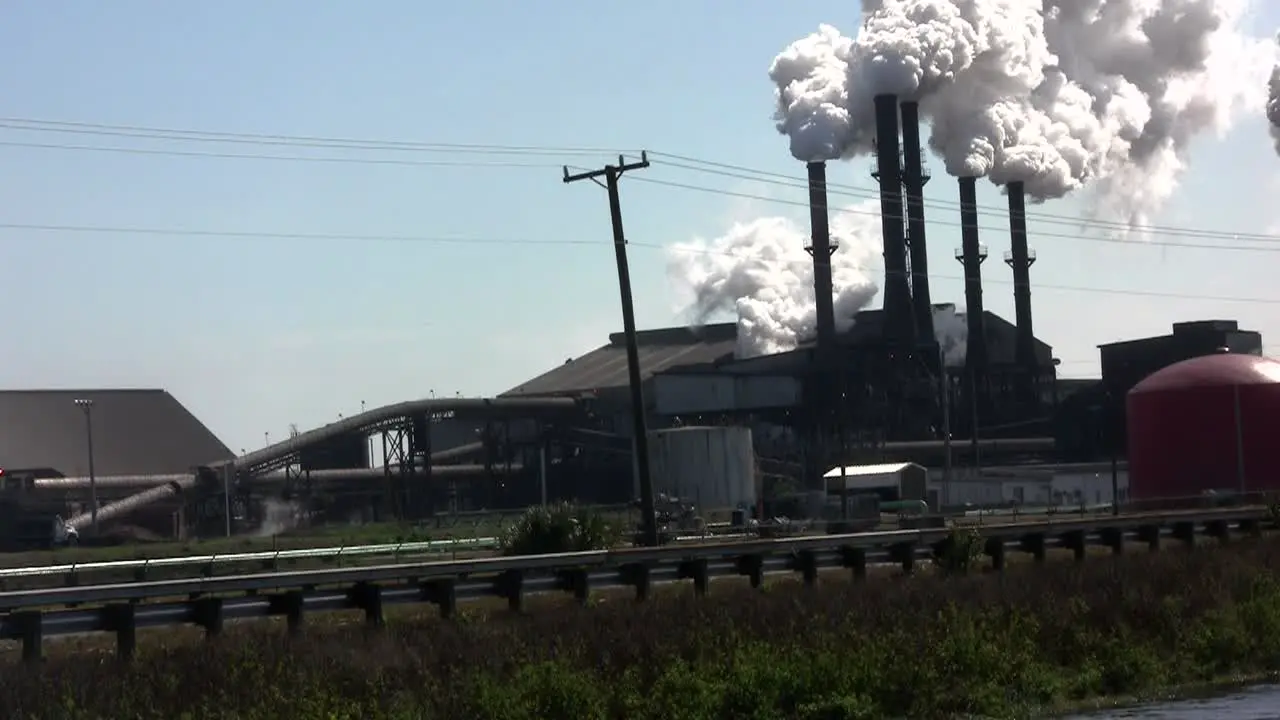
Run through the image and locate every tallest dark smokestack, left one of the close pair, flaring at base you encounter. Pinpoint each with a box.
[872,95,915,347]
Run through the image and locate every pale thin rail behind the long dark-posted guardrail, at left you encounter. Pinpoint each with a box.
[0,537,498,589]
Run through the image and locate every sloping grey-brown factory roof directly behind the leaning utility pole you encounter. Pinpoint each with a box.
[502,323,737,397]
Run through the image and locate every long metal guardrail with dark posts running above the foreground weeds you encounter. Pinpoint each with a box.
[0,507,1276,661]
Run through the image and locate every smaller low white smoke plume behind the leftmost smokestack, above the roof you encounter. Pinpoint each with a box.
[667,201,881,357]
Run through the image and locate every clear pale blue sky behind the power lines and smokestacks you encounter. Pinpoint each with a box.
[0,0,1280,450]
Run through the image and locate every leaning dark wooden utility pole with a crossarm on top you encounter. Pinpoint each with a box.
[564,152,658,547]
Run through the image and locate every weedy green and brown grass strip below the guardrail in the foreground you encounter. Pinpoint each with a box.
[0,536,1280,720]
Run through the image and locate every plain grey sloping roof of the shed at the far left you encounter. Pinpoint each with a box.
[0,389,234,475]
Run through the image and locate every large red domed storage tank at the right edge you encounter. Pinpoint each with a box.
[1126,352,1280,500]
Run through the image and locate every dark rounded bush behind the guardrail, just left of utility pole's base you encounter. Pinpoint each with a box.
[498,502,620,555]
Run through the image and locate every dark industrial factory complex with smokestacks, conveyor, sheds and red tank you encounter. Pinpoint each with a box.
[0,95,1280,544]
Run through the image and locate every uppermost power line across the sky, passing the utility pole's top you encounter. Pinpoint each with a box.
[0,118,1280,242]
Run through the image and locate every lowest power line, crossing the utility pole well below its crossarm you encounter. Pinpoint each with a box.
[0,221,1280,305]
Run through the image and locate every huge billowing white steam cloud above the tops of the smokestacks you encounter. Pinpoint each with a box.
[769,0,1277,224]
